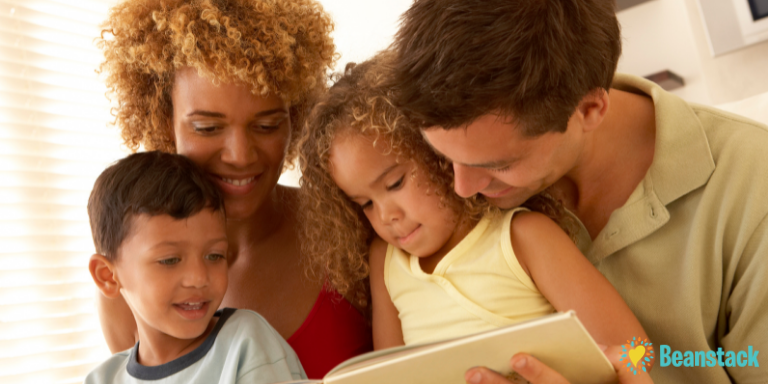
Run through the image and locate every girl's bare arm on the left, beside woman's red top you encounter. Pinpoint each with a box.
[370,237,405,350]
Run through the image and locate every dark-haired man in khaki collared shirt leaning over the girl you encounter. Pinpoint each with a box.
[393,0,768,383]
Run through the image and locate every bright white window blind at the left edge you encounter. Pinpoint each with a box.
[0,0,127,383]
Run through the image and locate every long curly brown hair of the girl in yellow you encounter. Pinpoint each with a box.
[298,51,572,306]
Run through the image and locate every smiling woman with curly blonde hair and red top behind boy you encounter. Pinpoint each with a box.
[98,0,371,378]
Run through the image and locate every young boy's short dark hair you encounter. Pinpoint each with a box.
[88,151,224,260]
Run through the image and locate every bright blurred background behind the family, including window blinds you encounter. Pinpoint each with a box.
[0,0,768,383]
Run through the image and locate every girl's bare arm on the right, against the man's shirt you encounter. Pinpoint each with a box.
[510,212,647,345]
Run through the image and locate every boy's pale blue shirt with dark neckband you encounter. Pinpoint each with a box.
[85,308,306,384]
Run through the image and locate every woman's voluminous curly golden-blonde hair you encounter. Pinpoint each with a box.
[97,0,336,162]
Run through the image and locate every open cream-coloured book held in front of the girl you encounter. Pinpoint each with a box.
[284,311,616,384]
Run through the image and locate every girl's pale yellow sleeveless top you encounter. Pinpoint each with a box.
[384,208,554,345]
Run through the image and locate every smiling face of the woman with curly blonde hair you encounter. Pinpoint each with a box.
[171,68,291,220]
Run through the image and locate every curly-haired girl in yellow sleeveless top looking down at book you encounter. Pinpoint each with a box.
[299,53,646,378]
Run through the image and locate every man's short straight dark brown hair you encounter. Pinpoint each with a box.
[393,0,621,136]
